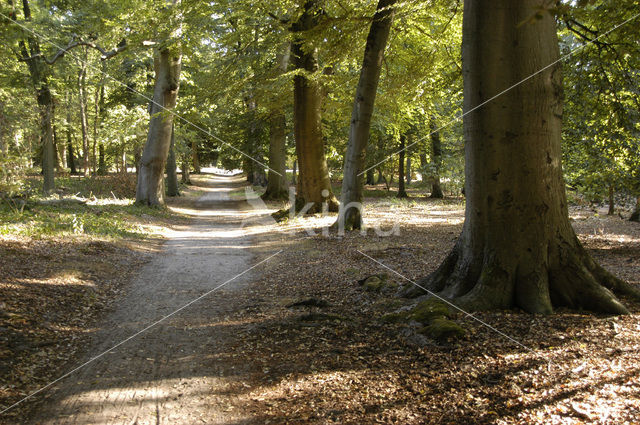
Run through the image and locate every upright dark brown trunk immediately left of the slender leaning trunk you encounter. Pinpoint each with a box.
[292,0,338,214]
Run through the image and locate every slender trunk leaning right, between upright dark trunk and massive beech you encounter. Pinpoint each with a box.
[337,0,396,230]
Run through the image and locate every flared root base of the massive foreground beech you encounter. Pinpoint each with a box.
[402,239,640,314]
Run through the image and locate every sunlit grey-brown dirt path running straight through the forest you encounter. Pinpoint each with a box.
[32,175,262,425]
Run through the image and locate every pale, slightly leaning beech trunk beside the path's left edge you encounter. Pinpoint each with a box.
[136,49,181,205]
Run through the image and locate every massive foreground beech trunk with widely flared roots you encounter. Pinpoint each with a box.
[412,0,639,313]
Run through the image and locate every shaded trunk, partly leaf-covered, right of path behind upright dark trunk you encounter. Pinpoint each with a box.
[262,43,291,199]
